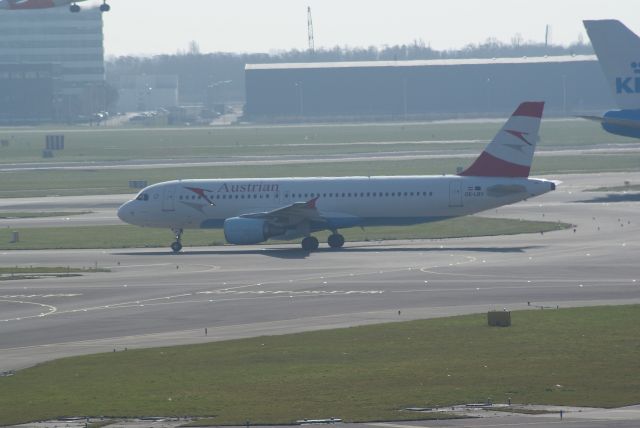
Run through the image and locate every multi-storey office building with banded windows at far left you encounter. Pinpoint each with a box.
[0,7,106,123]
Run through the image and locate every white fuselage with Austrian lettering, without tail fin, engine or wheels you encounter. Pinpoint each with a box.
[118,175,555,239]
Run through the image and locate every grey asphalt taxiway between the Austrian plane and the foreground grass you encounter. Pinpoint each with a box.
[0,173,640,371]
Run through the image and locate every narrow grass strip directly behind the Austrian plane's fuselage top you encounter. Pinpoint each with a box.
[0,153,640,198]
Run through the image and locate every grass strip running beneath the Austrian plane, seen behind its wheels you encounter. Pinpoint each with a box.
[0,216,570,250]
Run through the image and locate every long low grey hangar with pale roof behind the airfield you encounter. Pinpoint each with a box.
[245,55,613,122]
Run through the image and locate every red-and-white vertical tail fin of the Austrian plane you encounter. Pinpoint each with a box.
[460,101,544,177]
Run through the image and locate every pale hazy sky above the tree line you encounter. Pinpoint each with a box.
[101,0,640,56]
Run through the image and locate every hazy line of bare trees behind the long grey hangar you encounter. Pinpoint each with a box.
[106,35,593,104]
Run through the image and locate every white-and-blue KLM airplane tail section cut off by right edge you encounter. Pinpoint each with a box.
[581,19,640,138]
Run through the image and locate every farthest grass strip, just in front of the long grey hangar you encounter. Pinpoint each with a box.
[0,119,629,163]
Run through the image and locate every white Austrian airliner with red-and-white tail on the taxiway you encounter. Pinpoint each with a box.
[118,102,556,253]
